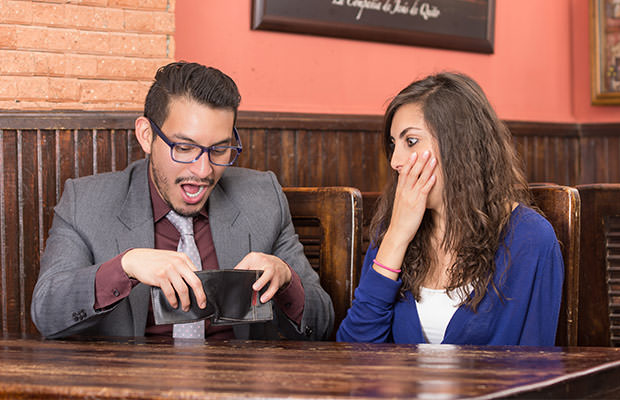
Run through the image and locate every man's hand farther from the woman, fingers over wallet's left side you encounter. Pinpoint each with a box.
[121,249,207,311]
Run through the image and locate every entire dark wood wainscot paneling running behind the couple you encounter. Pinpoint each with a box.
[0,111,620,333]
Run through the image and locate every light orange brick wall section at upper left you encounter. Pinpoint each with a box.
[0,0,176,110]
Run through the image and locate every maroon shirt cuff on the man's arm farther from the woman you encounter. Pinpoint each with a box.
[94,250,139,310]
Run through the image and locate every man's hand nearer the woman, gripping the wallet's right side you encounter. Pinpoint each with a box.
[235,252,291,303]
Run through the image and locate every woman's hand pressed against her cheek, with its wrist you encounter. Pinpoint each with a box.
[386,151,437,246]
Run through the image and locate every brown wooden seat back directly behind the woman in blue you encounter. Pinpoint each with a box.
[363,184,580,346]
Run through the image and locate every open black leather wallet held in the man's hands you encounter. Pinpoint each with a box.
[151,270,273,325]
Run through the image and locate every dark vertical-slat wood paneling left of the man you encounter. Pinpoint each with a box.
[0,119,142,335]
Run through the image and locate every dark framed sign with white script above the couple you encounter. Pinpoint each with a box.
[252,0,495,53]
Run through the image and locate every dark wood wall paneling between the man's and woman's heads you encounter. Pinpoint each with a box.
[237,112,390,191]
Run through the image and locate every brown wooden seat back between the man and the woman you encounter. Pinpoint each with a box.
[284,187,362,339]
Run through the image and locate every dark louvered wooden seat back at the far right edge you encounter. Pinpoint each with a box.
[577,183,620,347]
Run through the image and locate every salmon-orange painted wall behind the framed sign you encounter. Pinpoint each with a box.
[175,0,620,122]
